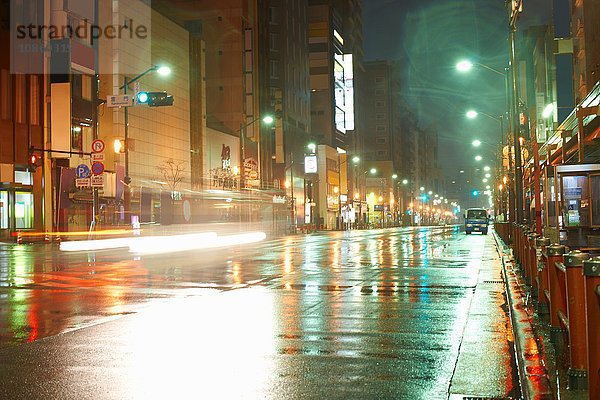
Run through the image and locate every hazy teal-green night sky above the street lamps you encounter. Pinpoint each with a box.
[363,0,551,194]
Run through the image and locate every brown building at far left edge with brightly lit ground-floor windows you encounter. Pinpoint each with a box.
[0,1,44,240]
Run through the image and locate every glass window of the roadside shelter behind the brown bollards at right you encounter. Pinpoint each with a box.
[562,176,590,227]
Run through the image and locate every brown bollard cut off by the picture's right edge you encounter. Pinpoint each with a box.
[583,257,600,399]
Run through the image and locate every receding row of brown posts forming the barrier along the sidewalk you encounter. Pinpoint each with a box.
[498,224,600,399]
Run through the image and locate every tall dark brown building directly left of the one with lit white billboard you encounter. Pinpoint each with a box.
[258,0,311,225]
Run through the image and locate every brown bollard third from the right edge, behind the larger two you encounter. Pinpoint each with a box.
[544,243,567,343]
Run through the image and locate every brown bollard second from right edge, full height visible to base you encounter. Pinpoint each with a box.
[564,250,590,390]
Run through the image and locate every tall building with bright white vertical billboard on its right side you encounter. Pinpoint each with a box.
[308,0,362,228]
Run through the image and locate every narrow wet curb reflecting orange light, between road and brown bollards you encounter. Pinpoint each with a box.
[493,231,556,400]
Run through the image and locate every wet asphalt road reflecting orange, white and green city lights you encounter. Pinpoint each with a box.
[0,228,519,399]
